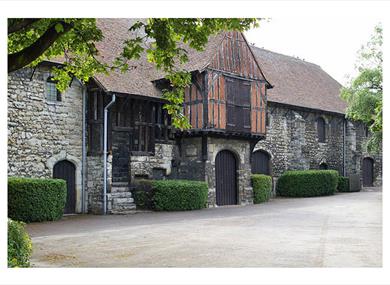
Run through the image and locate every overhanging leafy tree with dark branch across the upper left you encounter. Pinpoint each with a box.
[8,18,259,129]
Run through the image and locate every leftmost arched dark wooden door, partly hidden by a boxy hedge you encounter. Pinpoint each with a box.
[53,160,76,214]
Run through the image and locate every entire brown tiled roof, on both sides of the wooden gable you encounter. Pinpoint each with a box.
[54,18,346,113]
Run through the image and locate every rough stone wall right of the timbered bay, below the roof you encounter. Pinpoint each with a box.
[254,103,382,185]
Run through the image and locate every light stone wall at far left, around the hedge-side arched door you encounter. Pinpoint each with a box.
[8,67,82,211]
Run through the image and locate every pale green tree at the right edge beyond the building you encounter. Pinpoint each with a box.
[341,24,383,152]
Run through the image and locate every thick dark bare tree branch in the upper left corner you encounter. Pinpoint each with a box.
[8,22,73,72]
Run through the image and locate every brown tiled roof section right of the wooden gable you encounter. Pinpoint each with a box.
[251,46,347,114]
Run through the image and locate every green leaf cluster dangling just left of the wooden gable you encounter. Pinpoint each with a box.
[116,18,258,129]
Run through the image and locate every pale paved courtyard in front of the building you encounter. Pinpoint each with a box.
[27,188,382,267]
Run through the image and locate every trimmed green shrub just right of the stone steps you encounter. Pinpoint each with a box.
[153,180,208,211]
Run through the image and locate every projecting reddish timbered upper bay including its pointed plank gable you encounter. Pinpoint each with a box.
[184,29,267,136]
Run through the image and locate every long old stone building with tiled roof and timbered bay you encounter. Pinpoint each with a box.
[8,19,382,214]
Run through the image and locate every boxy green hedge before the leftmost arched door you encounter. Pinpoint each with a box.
[8,177,66,223]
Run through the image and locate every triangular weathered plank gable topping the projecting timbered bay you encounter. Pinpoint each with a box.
[208,31,264,80]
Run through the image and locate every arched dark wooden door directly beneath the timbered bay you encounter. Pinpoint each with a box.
[215,150,237,206]
